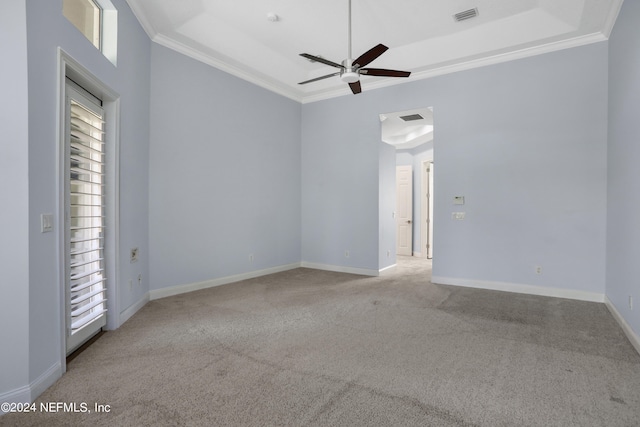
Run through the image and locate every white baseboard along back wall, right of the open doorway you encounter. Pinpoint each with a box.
[431,276,605,302]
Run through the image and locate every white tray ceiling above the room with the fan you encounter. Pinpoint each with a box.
[127,0,623,102]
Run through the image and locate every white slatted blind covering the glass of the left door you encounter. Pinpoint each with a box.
[67,99,107,335]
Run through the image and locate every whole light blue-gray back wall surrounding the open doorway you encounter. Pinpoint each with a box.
[302,43,607,294]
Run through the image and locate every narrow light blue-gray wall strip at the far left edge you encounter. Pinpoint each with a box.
[0,0,30,402]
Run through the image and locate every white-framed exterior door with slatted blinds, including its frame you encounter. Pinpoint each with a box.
[55,49,120,372]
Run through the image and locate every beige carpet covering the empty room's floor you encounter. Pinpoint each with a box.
[0,258,640,426]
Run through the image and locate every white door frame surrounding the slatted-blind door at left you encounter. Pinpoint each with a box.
[55,48,120,373]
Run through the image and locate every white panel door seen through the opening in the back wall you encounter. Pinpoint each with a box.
[396,166,413,256]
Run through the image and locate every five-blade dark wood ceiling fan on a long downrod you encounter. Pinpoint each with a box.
[298,0,411,95]
